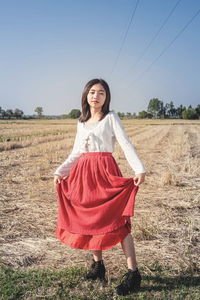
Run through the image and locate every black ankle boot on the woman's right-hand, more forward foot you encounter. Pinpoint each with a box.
[116,268,142,296]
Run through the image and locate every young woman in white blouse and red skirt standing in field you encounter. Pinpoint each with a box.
[54,79,146,295]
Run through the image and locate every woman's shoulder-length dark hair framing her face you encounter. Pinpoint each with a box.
[79,78,111,122]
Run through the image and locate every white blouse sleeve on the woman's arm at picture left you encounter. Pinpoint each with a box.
[54,123,81,177]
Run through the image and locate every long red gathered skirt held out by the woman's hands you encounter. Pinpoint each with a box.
[55,152,139,250]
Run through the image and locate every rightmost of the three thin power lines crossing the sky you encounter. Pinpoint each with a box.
[126,9,200,85]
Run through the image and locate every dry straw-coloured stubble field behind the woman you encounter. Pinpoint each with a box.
[0,120,200,299]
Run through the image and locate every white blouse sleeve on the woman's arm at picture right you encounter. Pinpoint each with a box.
[112,112,147,175]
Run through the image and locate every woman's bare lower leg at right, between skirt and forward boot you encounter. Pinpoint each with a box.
[121,233,137,270]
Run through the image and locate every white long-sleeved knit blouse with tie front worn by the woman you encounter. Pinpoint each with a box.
[54,111,147,177]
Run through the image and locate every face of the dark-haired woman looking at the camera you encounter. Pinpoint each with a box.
[87,83,106,108]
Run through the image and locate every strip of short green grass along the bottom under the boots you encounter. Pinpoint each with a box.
[0,261,200,300]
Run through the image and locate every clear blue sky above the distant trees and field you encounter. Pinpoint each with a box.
[0,0,200,115]
